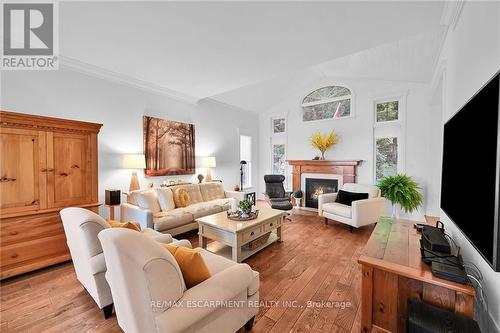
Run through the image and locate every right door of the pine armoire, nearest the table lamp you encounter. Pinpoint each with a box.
[47,132,92,207]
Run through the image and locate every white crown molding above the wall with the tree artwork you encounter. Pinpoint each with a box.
[59,55,199,104]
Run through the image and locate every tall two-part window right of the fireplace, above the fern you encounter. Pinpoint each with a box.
[373,96,406,181]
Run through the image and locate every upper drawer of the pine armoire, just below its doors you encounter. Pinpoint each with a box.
[0,213,66,246]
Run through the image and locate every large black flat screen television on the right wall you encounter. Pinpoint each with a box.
[441,72,500,271]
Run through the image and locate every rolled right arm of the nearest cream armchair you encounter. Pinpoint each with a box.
[156,264,254,332]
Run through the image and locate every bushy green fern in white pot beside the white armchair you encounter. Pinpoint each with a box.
[378,174,423,218]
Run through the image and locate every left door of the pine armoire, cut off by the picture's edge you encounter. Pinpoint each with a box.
[0,128,47,214]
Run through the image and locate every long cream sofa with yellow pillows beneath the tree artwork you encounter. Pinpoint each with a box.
[120,182,244,236]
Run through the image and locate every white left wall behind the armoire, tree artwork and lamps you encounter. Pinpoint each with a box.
[1,69,258,216]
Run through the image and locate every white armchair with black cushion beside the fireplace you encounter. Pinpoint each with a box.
[318,183,385,232]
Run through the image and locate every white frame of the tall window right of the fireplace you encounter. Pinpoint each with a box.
[372,91,408,183]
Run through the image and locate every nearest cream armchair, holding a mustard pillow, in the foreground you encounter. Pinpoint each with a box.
[99,228,259,333]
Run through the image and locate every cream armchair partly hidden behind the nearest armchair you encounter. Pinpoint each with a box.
[60,207,191,319]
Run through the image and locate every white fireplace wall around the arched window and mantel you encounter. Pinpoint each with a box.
[259,77,430,220]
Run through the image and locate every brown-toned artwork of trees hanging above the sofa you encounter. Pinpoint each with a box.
[143,116,195,176]
